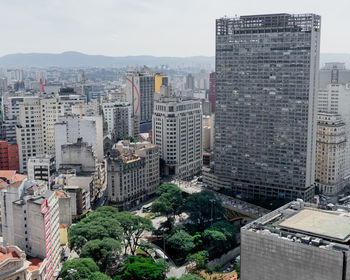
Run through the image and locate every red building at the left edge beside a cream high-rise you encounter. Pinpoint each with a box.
[0,140,19,171]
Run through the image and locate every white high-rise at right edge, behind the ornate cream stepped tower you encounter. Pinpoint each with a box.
[318,83,350,181]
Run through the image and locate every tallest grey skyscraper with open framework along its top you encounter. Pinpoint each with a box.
[214,14,321,199]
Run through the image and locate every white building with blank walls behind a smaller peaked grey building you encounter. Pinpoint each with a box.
[55,116,103,169]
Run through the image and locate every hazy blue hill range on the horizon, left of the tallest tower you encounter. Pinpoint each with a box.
[0,52,215,69]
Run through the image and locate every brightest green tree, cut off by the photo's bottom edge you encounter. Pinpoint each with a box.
[114,256,166,280]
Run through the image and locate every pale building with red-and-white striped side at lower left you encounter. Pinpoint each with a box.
[12,191,61,280]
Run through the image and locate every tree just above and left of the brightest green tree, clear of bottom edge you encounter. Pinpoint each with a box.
[80,238,121,272]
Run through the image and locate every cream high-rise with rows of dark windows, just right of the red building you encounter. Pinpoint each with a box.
[16,97,64,172]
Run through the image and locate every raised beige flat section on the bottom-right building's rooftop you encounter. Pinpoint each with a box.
[277,208,350,242]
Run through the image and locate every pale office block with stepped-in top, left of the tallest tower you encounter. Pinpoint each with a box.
[152,91,202,178]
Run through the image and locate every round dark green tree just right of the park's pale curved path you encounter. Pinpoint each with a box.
[165,230,195,258]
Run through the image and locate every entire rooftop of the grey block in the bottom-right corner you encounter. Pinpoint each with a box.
[241,199,350,251]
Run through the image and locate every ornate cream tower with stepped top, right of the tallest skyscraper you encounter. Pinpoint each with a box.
[315,113,347,195]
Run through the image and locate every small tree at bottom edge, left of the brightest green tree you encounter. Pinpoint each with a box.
[60,258,99,280]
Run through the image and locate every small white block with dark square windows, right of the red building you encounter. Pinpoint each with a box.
[27,155,56,188]
